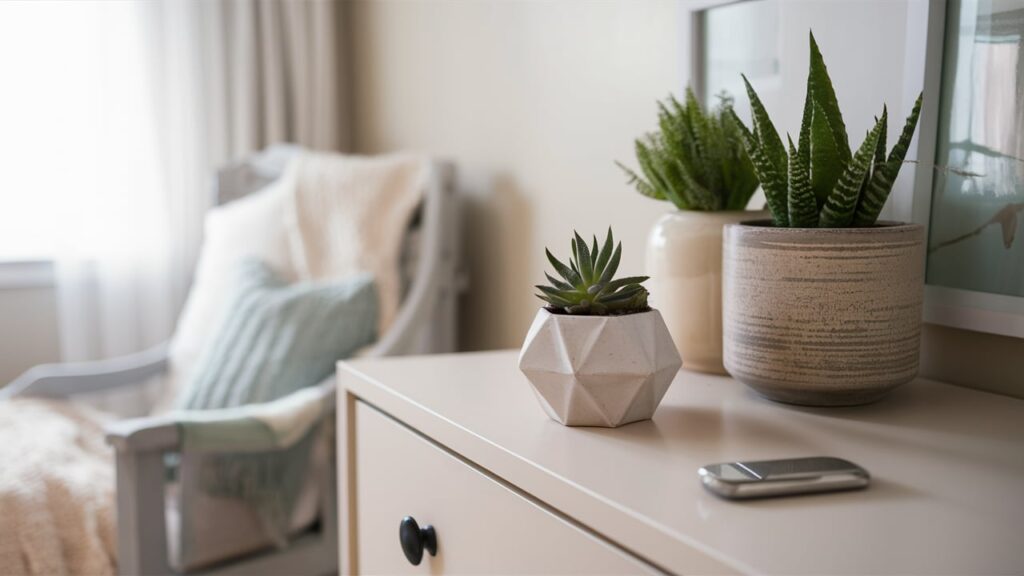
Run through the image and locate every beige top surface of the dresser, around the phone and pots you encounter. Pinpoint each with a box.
[339,351,1024,574]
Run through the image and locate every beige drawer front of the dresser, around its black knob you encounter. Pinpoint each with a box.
[353,402,653,574]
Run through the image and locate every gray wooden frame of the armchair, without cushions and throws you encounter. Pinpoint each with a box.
[0,147,465,575]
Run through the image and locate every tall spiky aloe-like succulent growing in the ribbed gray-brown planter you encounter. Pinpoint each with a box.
[727,33,922,228]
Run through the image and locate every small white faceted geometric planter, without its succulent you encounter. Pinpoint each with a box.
[519,308,682,427]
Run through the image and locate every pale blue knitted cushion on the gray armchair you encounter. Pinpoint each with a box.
[175,258,378,410]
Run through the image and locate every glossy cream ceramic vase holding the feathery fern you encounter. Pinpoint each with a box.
[646,210,768,374]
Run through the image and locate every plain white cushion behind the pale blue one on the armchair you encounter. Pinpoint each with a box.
[156,182,298,412]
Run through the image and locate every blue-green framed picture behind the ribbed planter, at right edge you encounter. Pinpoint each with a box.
[908,0,1024,337]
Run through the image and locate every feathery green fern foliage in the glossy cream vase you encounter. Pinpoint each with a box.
[616,88,758,210]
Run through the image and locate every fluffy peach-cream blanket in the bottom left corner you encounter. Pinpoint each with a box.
[0,399,117,576]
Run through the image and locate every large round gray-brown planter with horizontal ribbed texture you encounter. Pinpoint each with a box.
[722,220,925,406]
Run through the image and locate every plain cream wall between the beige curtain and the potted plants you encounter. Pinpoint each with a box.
[351,0,685,348]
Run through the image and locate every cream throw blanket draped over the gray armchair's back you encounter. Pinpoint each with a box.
[285,152,430,335]
